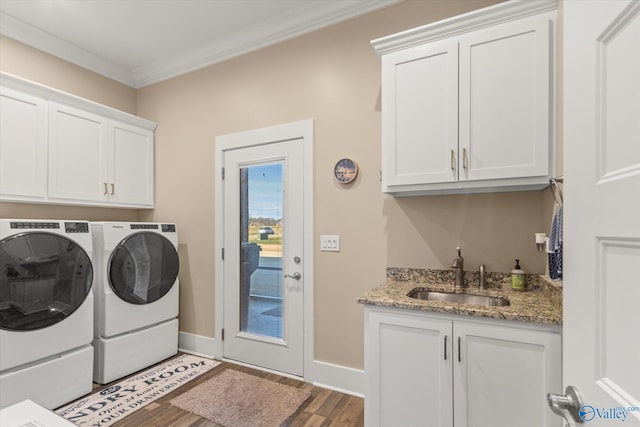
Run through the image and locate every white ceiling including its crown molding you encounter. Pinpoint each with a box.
[0,0,402,88]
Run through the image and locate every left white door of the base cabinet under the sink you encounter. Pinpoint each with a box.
[365,309,453,427]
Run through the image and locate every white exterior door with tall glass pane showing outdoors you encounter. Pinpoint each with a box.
[223,139,305,376]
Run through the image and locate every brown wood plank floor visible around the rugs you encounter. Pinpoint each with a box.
[94,362,364,427]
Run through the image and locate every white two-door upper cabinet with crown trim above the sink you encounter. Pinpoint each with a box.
[372,0,557,195]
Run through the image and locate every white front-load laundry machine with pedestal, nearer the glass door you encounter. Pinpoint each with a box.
[91,222,179,384]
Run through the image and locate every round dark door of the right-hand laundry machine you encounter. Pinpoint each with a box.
[108,231,179,305]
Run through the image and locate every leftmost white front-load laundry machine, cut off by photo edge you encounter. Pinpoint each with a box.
[0,219,93,409]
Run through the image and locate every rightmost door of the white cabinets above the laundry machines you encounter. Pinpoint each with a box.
[108,122,154,207]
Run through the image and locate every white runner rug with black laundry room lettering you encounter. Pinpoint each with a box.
[55,354,220,427]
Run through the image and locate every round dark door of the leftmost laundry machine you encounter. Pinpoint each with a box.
[0,232,93,331]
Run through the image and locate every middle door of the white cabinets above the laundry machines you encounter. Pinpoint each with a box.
[49,103,108,202]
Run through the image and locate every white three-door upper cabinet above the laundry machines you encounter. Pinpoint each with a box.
[0,74,156,208]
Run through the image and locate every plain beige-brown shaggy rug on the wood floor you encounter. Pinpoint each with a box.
[171,369,311,427]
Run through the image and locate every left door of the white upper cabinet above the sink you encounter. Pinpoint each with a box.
[382,42,458,191]
